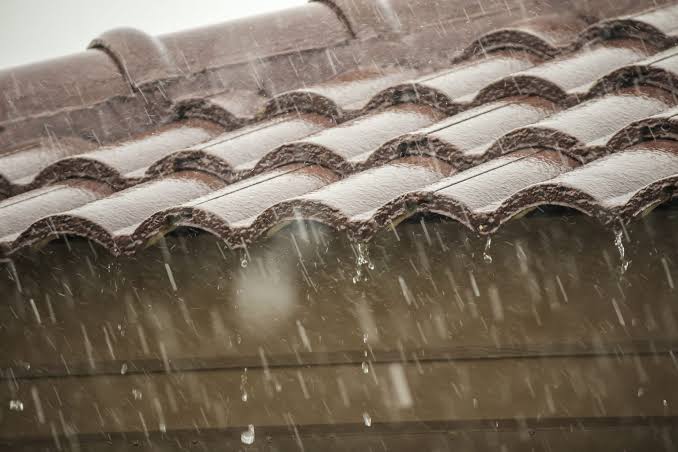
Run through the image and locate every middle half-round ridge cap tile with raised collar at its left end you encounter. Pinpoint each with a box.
[89,4,350,88]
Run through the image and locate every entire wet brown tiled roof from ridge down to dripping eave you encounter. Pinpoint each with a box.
[0,0,678,254]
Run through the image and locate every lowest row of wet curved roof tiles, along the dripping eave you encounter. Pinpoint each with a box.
[0,136,678,254]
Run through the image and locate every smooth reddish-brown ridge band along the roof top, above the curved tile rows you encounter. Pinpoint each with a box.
[0,0,675,148]
